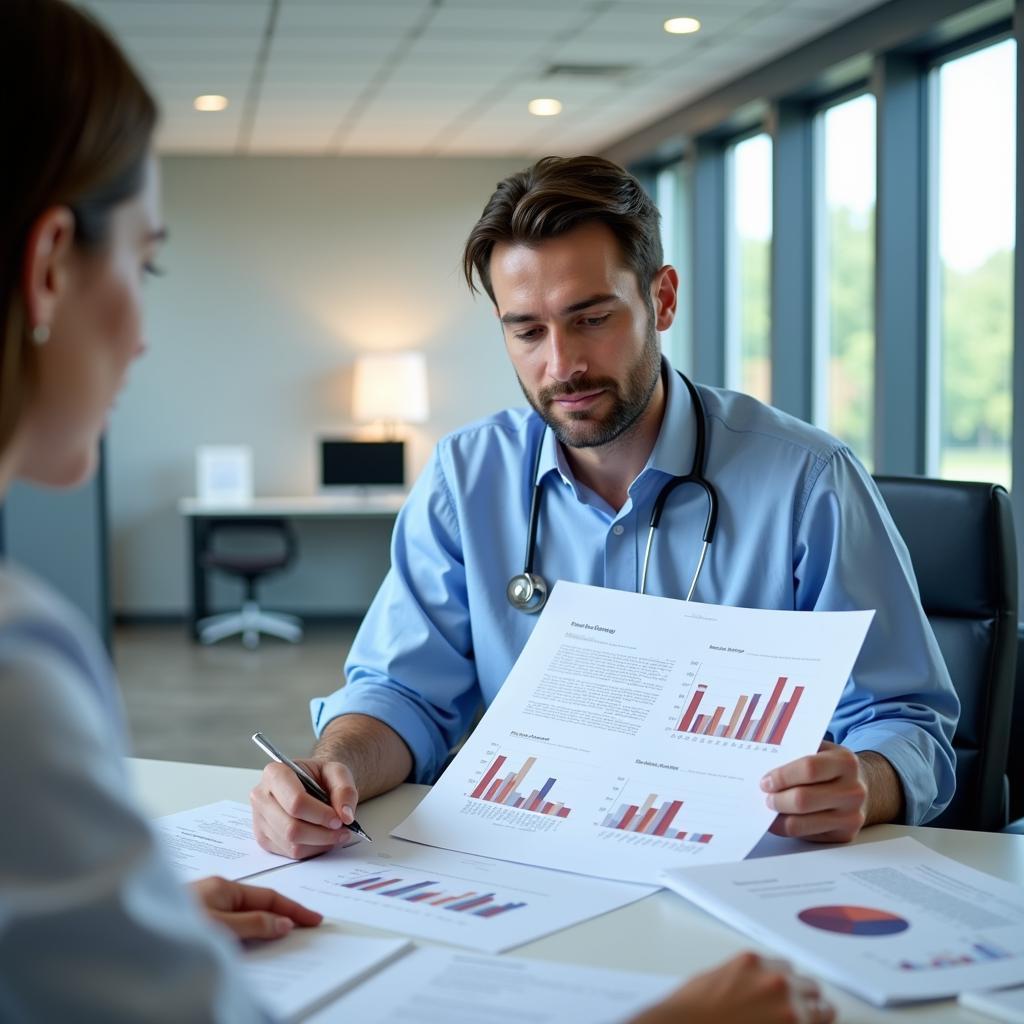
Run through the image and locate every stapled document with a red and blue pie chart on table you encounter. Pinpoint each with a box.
[663,839,1024,1006]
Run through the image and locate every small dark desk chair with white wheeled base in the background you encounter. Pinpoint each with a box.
[196,518,302,648]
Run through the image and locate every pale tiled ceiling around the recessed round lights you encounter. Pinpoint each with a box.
[96,0,892,155]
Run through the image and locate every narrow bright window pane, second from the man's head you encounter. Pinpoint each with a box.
[725,134,772,401]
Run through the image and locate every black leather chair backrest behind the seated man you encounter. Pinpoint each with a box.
[877,476,1017,830]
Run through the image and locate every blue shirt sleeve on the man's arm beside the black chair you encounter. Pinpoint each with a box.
[794,449,959,824]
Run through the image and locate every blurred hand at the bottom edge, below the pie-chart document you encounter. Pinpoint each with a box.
[632,953,836,1024]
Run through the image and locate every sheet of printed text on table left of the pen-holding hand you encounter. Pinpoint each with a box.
[154,800,291,882]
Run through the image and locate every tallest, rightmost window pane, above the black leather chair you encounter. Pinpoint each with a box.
[929,40,1016,486]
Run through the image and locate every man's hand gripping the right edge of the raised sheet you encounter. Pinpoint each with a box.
[761,741,903,843]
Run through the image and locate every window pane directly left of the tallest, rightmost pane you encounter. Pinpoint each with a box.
[814,95,876,467]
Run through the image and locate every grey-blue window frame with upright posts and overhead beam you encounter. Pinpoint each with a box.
[605,0,1024,571]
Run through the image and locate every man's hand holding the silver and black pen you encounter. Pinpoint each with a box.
[249,760,359,860]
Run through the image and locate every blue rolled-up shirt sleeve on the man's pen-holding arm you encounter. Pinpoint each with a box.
[310,447,480,782]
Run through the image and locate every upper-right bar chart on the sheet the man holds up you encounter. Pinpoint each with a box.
[675,676,804,746]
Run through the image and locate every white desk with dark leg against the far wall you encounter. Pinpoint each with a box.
[178,492,407,639]
